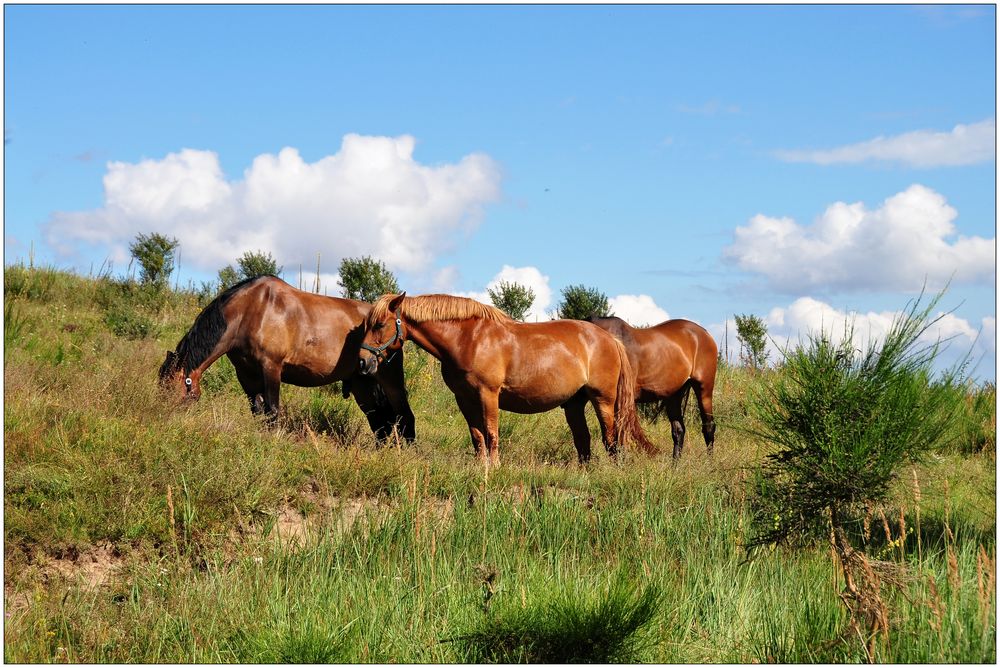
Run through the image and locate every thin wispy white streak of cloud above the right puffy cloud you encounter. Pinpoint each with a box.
[775,118,996,167]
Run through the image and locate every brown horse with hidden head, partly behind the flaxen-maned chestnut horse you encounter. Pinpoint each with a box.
[587,316,719,459]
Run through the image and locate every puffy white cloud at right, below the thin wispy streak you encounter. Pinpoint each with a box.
[723,185,996,294]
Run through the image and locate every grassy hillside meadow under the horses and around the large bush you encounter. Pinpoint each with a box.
[4,265,996,663]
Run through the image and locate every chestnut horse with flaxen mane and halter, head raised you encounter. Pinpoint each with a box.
[360,293,655,465]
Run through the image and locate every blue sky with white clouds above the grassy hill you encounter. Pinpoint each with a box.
[4,5,996,378]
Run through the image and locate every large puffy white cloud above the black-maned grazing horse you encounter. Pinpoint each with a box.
[46,134,500,271]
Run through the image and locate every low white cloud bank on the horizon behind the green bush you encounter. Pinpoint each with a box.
[708,297,996,378]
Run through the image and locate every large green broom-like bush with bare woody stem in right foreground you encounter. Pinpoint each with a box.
[748,293,964,661]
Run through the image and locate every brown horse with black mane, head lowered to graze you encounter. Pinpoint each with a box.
[160,276,414,440]
